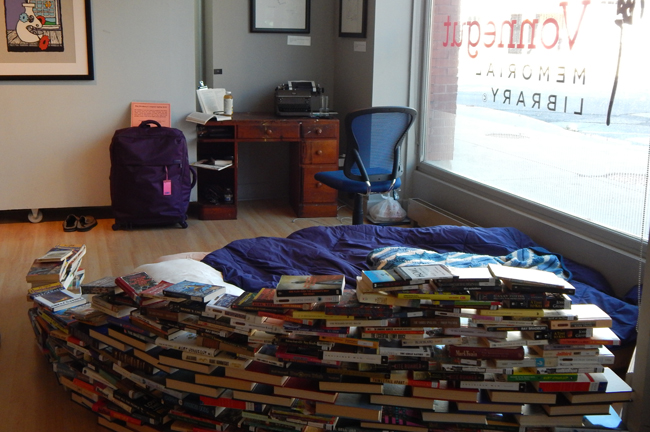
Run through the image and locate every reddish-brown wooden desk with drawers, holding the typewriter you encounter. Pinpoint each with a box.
[197,113,339,220]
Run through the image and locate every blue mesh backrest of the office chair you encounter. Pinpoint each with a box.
[343,106,417,182]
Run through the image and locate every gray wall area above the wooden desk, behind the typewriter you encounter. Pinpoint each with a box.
[204,0,338,112]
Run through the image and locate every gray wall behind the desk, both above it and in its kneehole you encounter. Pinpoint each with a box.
[204,0,338,200]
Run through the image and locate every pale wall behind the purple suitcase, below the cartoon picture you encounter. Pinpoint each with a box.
[0,0,195,210]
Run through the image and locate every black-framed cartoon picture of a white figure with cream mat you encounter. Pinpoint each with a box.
[0,0,95,80]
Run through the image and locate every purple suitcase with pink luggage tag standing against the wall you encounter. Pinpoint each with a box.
[110,120,196,230]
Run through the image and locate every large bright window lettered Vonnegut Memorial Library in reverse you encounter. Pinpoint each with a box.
[422,0,650,243]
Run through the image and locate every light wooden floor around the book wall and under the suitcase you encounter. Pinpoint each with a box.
[0,201,351,432]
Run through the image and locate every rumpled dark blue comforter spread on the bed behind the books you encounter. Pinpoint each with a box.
[203,225,638,344]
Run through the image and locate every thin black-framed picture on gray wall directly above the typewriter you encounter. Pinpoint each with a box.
[250,0,311,33]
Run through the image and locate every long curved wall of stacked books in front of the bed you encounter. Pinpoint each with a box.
[30,258,632,432]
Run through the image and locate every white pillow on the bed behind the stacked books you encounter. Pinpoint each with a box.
[133,258,244,294]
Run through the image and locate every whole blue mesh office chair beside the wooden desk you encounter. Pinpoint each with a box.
[314,106,417,225]
